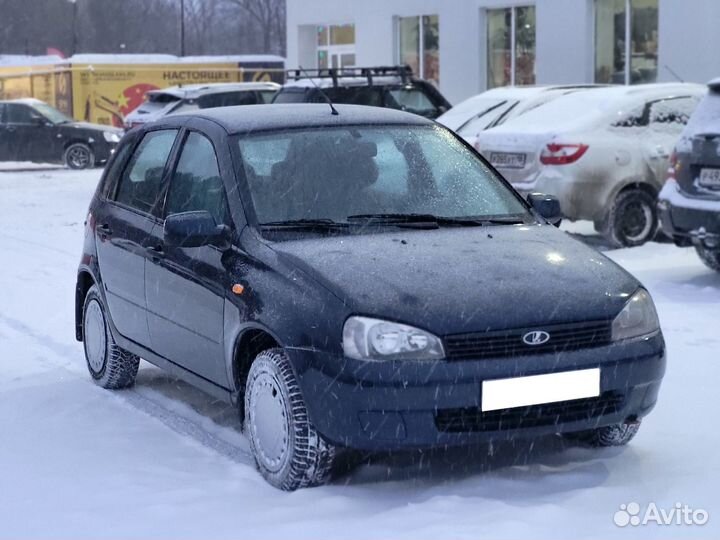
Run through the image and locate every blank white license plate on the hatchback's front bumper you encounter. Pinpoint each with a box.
[482,368,600,411]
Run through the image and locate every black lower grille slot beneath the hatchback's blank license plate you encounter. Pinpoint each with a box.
[435,392,624,433]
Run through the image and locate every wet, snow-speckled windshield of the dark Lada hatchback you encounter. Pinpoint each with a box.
[237,126,531,225]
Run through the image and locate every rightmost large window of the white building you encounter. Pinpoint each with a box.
[595,0,658,84]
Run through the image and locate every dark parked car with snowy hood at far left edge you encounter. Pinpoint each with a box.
[0,99,122,169]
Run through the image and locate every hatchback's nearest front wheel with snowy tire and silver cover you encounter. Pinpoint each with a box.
[244,349,336,491]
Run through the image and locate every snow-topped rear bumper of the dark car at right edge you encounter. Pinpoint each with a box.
[658,182,720,247]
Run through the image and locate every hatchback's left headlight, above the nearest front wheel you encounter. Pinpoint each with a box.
[343,317,445,361]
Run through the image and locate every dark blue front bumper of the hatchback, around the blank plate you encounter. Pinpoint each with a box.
[288,334,666,451]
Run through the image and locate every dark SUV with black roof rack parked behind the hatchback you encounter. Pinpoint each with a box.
[273,66,451,118]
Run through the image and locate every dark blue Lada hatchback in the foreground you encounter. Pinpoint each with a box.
[76,105,665,490]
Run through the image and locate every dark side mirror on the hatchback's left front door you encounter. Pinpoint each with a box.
[164,210,230,249]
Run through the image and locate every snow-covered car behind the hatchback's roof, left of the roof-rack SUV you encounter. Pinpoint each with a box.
[125,82,280,129]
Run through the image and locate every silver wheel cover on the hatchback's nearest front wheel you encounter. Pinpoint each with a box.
[248,373,290,472]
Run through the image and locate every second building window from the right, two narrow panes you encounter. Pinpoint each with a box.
[487,6,535,88]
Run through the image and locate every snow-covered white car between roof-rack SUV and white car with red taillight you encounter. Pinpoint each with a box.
[437,84,602,145]
